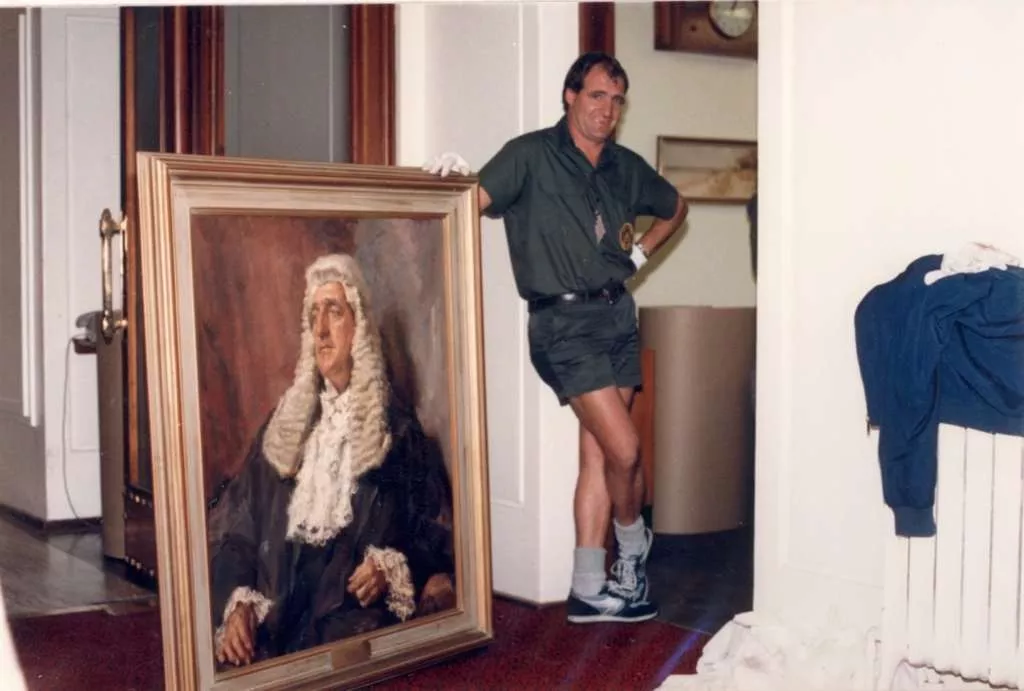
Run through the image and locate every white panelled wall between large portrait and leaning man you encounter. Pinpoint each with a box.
[397,3,579,602]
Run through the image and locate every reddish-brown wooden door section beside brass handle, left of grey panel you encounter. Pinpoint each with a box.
[121,6,223,578]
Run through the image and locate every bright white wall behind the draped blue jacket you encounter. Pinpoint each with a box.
[755,0,1024,629]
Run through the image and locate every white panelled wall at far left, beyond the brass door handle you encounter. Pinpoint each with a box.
[0,8,114,521]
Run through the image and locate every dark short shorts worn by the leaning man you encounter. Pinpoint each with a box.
[528,292,641,405]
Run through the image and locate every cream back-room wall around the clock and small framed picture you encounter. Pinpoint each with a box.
[615,2,758,307]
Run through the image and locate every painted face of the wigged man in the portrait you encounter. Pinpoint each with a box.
[309,283,355,391]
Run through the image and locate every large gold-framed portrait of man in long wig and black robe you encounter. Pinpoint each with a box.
[138,154,493,691]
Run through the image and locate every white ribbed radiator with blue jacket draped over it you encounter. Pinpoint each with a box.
[879,425,1024,689]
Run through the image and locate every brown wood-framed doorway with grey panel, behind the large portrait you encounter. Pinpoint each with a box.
[111,5,394,584]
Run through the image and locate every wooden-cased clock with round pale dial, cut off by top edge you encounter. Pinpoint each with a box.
[654,0,758,58]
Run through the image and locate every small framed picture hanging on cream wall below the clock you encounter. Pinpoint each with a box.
[657,135,758,204]
